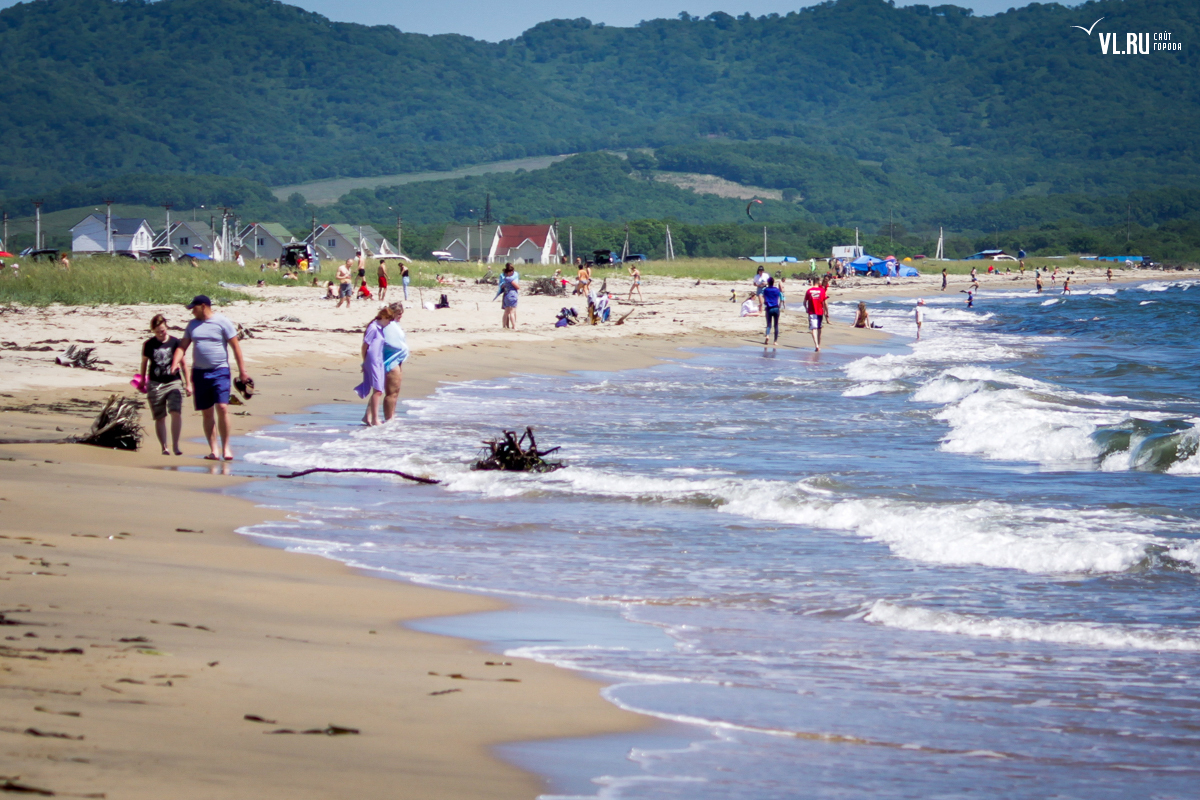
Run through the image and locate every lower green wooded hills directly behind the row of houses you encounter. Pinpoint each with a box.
[9,159,1200,261]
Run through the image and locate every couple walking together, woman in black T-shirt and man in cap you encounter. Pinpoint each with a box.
[133,295,254,461]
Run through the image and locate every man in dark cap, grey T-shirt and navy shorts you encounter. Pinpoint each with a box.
[170,295,250,461]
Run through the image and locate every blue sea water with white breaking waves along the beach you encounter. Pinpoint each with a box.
[242,282,1200,799]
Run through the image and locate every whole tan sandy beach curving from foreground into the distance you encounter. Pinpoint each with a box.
[0,270,1142,798]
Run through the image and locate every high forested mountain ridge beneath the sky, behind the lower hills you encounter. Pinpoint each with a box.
[0,0,1200,225]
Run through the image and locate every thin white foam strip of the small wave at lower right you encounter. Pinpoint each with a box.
[864,600,1200,652]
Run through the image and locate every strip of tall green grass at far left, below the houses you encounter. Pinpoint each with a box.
[0,255,312,306]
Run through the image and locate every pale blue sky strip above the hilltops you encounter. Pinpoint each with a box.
[0,0,1028,42]
